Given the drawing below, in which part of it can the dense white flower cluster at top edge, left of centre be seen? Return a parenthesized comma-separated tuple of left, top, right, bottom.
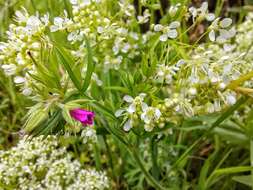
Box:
(50, 0, 140, 70)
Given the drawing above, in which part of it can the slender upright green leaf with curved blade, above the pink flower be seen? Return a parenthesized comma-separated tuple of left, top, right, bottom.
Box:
(82, 37, 95, 92)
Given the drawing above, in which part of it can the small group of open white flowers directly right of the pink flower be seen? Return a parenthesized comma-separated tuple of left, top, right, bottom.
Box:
(115, 93, 164, 131)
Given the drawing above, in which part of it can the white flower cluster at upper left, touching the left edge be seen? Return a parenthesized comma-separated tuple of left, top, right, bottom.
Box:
(0, 8, 49, 95)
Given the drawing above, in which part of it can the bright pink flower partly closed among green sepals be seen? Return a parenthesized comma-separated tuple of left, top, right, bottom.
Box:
(70, 109, 95, 125)
